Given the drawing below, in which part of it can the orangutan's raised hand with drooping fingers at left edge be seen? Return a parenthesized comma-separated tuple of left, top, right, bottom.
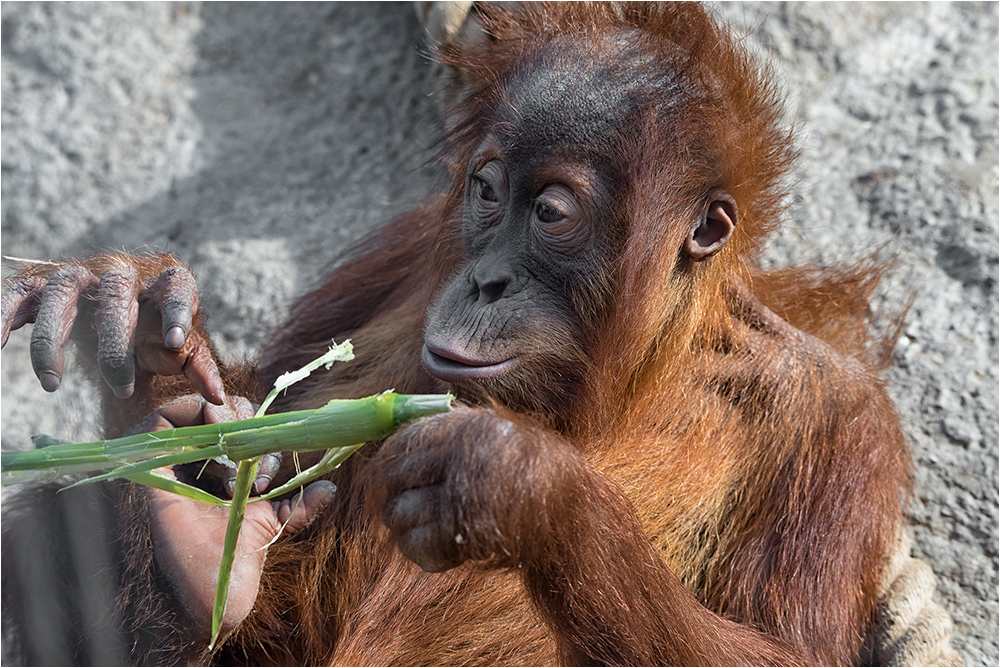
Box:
(2, 253, 225, 406)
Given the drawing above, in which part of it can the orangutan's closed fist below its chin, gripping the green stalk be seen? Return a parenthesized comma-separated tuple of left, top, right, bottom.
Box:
(367, 408, 590, 572)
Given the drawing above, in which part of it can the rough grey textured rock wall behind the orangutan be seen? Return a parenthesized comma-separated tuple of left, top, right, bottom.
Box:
(2, 2, 998, 665)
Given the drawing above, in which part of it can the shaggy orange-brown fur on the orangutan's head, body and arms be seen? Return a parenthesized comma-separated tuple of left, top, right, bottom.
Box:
(0, 3, 908, 665)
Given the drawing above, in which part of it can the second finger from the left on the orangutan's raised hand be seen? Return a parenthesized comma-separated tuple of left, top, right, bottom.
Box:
(31, 267, 97, 392)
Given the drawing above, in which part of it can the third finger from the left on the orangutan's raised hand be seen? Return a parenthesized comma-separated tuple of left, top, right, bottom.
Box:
(97, 264, 139, 399)
